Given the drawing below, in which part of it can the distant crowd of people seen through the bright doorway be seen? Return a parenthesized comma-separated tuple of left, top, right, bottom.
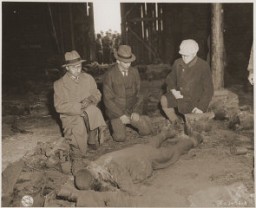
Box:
(95, 29, 121, 64)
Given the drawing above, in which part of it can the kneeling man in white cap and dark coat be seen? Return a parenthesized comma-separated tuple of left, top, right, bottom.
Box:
(161, 39, 213, 123)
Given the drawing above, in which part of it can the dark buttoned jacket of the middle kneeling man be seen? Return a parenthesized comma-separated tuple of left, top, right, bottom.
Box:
(103, 65, 142, 119)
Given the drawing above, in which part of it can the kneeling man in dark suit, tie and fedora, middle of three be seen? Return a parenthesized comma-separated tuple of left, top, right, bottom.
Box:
(103, 45, 152, 141)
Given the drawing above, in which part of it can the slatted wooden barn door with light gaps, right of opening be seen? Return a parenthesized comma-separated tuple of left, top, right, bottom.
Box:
(121, 3, 163, 64)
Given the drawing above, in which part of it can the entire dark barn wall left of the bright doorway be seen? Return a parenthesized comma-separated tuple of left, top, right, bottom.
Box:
(2, 2, 94, 77)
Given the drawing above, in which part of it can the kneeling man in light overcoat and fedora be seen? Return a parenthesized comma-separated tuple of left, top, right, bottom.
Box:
(54, 50, 106, 155)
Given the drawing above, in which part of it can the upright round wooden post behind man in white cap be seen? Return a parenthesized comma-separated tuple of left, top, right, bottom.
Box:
(211, 3, 224, 90)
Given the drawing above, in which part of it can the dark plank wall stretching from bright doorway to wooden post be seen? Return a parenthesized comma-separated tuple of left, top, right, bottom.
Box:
(121, 3, 210, 64)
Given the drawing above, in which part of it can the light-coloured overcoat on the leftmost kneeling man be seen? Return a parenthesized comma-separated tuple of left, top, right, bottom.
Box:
(54, 73, 105, 130)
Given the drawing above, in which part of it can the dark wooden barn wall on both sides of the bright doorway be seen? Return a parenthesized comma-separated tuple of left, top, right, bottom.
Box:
(2, 2, 253, 77)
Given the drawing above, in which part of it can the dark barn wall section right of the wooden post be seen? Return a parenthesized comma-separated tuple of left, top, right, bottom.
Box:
(223, 3, 253, 83)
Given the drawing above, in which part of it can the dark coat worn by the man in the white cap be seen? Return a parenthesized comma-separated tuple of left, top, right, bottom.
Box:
(166, 57, 213, 114)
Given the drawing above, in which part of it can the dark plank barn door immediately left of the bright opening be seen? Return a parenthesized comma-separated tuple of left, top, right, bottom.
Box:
(49, 3, 95, 60)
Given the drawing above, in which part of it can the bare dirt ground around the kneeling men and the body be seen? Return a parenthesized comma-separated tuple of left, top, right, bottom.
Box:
(2, 66, 255, 207)
